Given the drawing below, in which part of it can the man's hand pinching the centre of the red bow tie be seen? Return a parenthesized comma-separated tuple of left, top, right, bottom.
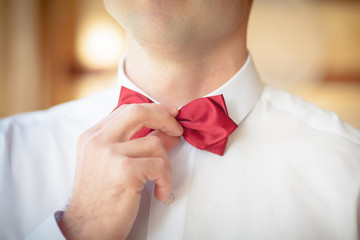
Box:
(59, 104, 183, 239)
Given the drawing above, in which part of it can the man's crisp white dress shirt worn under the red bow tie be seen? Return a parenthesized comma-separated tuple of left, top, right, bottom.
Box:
(0, 56, 360, 240)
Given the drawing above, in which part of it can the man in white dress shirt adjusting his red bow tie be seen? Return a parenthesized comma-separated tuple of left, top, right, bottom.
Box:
(0, 0, 360, 239)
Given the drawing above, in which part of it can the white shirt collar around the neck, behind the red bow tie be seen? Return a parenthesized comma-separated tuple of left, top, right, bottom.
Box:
(117, 55, 264, 124)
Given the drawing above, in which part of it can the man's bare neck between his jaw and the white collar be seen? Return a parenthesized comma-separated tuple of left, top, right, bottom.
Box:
(125, 30, 248, 107)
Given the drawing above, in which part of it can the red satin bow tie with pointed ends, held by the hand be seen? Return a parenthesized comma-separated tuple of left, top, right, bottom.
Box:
(116, 87, 237, 156)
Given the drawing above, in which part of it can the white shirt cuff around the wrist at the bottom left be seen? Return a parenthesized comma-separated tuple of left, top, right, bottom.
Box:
(25, 211, 66, 240)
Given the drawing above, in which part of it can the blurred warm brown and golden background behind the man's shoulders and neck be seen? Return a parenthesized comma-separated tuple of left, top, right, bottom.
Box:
(0, 0, 360, 129)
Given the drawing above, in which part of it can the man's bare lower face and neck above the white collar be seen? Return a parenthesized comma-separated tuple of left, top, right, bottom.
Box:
(105, 0, 251, 107)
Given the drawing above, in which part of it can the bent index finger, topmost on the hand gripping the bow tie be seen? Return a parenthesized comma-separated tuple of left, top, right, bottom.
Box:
(102, 103, 183, 141)
